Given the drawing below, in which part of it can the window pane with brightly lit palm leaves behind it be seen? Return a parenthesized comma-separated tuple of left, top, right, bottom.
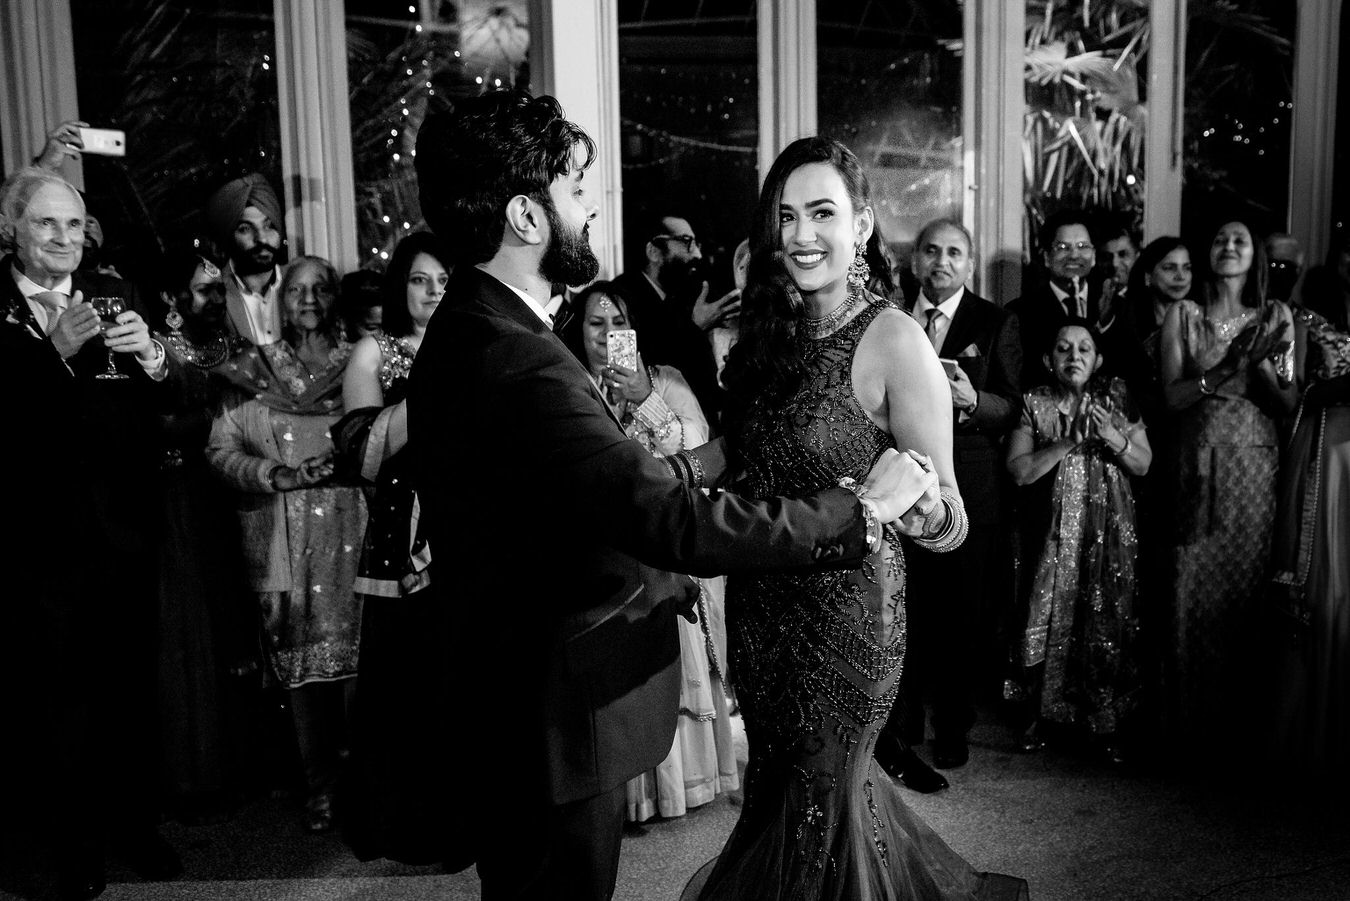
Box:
(1022, 0, 1149, 259)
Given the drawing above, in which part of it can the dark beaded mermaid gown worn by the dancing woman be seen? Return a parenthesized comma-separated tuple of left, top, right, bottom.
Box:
(686, 300, 1026, 901)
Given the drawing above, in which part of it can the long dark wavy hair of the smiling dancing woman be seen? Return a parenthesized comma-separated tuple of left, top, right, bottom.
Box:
(722, 136, 871, 438)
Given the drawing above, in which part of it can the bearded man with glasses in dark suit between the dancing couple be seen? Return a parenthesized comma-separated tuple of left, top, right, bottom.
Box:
(614, 209, 740, 428)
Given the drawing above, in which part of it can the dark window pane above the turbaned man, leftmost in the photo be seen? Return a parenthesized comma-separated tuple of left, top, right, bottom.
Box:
(69, 0, 281, 277)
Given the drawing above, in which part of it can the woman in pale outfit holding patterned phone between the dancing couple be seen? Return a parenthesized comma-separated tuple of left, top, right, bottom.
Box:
(564, 281, 740, 823)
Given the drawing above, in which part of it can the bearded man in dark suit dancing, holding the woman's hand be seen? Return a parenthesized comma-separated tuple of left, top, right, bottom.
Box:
(408, 92, 939, 901)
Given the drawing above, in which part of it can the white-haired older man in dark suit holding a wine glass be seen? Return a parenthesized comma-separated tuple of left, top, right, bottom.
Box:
(0, 169, 180, 898)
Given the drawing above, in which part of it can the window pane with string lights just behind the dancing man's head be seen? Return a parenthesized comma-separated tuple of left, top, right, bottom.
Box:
(346, 0, 529, 265)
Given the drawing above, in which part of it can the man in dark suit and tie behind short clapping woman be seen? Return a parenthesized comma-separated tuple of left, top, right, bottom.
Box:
(1007, 209, 1148, 388)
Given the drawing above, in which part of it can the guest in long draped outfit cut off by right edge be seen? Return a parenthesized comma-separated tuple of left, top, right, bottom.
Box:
(1272, 232, 1350, 789)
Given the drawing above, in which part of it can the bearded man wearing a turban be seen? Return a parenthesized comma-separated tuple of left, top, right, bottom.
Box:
(207, 173, 284, 344)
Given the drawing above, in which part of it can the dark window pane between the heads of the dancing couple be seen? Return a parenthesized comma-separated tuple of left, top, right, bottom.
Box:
(618, 0, 759, 282)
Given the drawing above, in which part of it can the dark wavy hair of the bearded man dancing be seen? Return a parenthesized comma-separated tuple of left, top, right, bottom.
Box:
(416, 89, 595, 265)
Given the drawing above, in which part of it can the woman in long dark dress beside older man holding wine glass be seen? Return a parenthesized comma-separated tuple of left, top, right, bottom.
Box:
(157, 253, 258, 823)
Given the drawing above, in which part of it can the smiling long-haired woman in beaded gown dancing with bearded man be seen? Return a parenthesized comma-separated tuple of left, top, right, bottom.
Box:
(684, 138, 1026, 901)
